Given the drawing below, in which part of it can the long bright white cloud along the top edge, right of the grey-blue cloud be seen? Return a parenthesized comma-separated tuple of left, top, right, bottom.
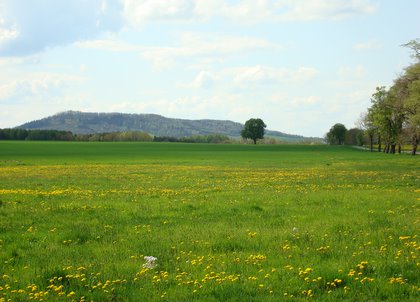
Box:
(124, 0, 376, 26)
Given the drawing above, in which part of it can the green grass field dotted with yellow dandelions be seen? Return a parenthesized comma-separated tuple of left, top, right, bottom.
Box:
(0, 142, 420, 301)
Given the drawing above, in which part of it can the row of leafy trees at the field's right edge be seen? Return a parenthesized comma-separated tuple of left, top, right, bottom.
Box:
(325, 39, 420, 155)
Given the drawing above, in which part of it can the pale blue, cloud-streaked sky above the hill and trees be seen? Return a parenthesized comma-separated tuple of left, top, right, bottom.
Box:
(0, 0, 420, 137)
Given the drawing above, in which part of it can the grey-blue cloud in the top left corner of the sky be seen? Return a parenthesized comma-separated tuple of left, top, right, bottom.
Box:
(0, 0, 122, 56)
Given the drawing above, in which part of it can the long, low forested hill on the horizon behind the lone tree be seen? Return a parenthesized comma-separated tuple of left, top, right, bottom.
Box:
(17, 111, 305, 141)
